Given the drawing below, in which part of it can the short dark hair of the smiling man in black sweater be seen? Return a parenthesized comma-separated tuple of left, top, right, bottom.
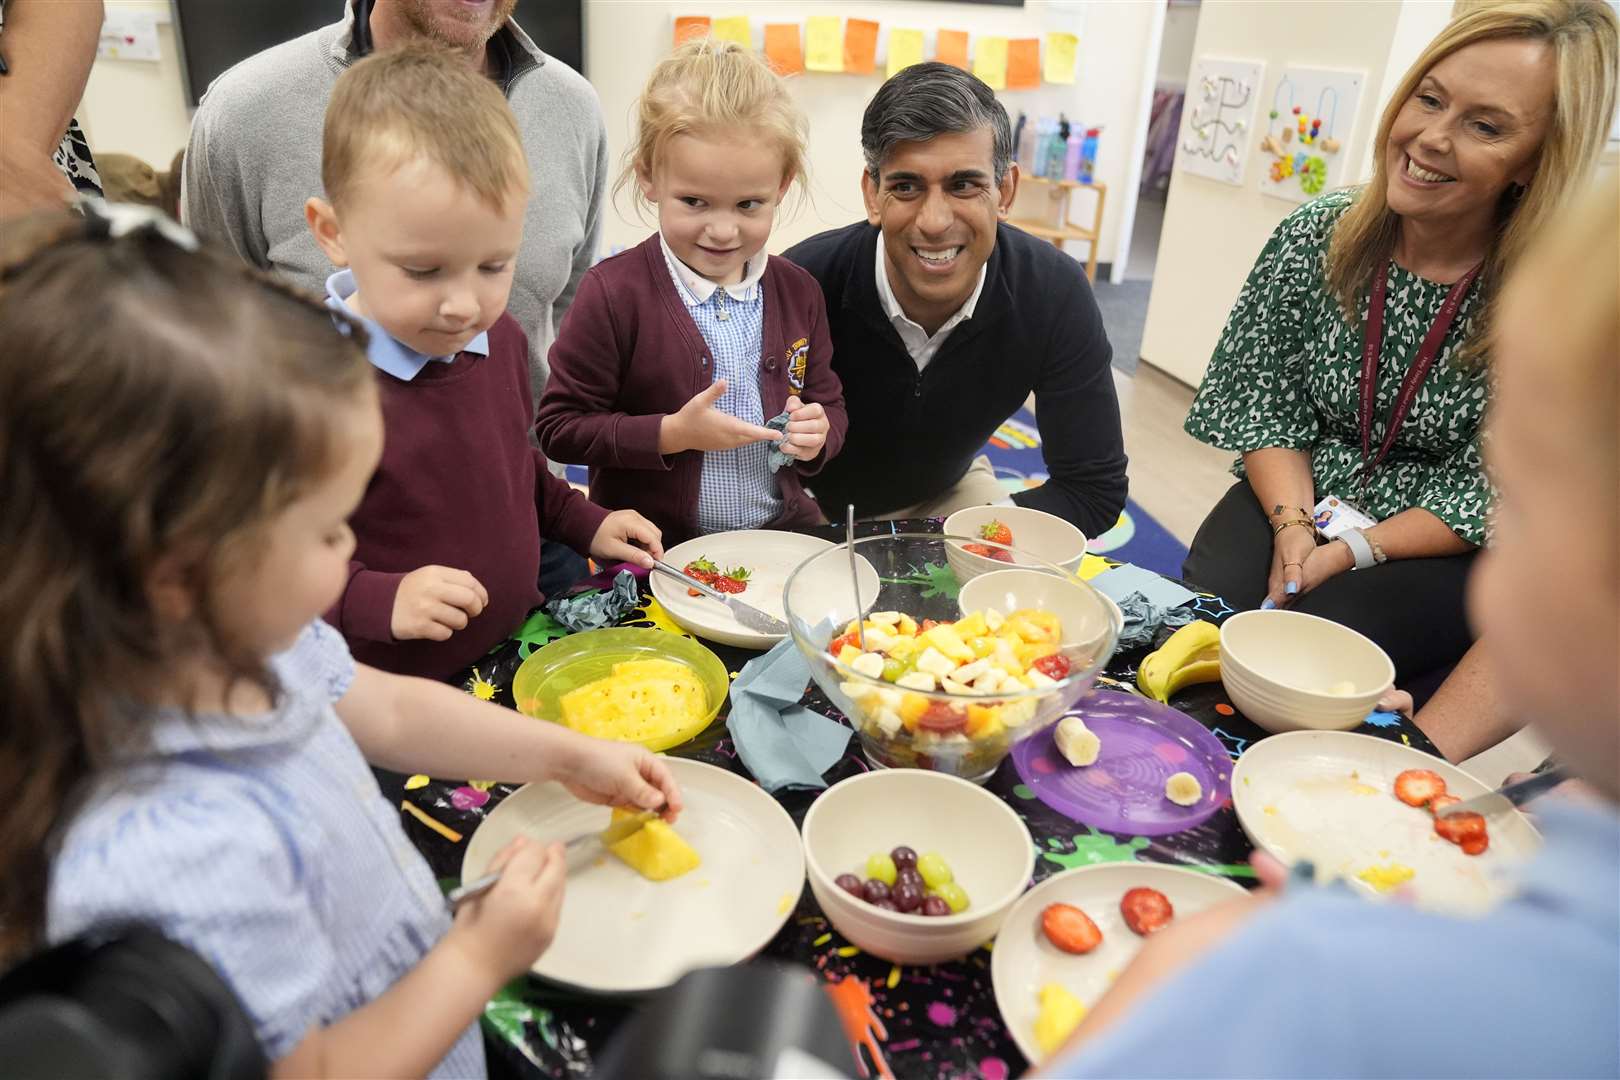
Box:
(860, 62, 1013, 185)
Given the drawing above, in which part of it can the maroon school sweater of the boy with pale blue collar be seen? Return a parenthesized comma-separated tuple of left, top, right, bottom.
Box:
(326, 314, 608, 678)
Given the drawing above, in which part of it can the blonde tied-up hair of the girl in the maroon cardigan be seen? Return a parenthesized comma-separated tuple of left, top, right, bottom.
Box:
(614, 37, 808, 207)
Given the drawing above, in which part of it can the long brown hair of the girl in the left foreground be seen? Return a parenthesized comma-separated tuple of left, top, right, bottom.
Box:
(0, 214, 374, 957)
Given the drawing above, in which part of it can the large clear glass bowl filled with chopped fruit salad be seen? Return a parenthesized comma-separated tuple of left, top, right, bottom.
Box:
(782, 533, 1119, 782)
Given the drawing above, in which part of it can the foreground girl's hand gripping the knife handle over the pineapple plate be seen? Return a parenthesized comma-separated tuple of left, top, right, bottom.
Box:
(446, 837, 569, 983)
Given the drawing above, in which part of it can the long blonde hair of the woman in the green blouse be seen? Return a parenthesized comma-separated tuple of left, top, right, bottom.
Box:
(1327, 0, 1620, 364)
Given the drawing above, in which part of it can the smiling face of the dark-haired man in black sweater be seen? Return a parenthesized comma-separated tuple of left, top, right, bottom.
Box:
(860, 126, 1017, 334)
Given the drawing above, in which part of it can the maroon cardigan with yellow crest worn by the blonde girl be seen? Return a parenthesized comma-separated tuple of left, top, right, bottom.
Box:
(535, 233, 849, 546)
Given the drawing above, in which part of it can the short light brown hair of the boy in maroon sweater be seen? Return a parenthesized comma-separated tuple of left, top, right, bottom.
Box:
(321, 45, 528, 209)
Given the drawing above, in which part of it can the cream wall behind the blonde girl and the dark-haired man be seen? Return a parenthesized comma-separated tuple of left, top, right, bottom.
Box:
(585, 0, 1162, 262)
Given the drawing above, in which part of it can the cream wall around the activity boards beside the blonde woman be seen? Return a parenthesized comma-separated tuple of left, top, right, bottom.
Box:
(1142, 0, 1452, 385)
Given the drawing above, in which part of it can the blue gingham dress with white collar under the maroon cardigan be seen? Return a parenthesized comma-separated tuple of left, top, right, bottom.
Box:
(663, 244, 782, 533)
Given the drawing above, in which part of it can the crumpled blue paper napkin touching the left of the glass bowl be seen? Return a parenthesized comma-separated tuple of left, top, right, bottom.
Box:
(726, 636, 851, 792)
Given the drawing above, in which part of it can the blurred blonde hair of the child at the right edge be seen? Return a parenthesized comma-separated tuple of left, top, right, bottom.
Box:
(1503, 175, 1620, 563)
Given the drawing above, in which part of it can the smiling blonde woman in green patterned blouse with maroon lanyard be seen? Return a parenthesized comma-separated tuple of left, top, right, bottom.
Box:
(1183, 0, 1620, 678)
